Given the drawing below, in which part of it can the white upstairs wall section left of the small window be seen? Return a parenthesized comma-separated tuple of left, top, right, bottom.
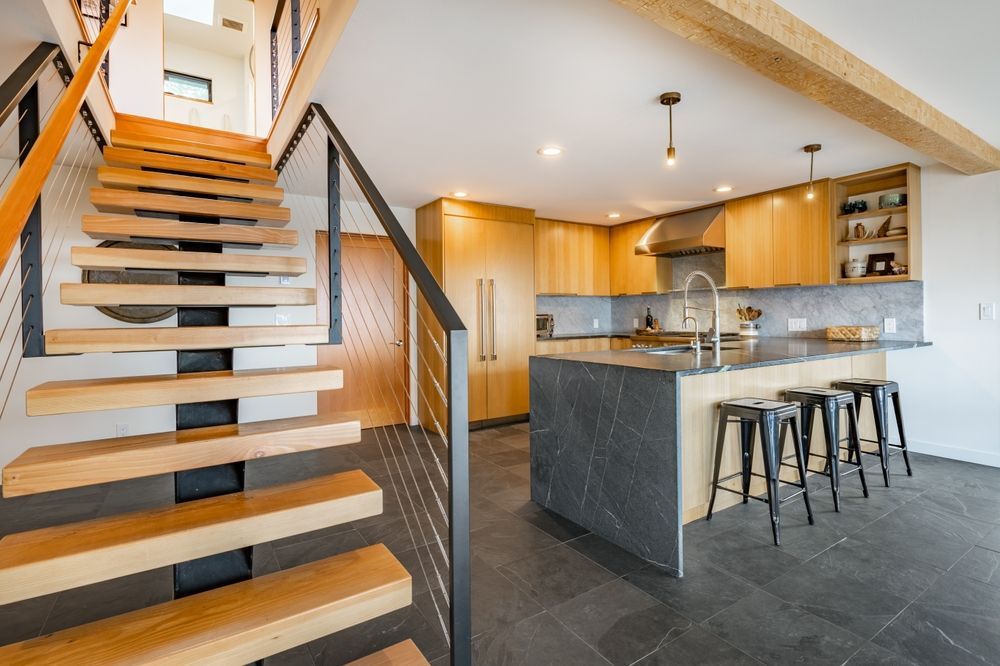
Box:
(108, 0, 163, 118)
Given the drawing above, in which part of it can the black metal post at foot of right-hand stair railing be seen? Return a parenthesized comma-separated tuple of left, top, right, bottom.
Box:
(447, 329, 472, 666)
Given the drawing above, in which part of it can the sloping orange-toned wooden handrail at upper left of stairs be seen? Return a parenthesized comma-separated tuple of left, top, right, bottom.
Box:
(0, 1, 131, 266)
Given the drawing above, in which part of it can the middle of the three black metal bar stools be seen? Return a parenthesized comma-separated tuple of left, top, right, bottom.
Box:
(785, 386, 868, 511)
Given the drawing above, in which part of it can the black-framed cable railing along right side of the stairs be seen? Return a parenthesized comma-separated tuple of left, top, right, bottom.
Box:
(277, 104, 471, 664)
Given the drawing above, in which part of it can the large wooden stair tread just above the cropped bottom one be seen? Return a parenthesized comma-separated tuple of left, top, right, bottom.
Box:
(0, 545, 412, 666)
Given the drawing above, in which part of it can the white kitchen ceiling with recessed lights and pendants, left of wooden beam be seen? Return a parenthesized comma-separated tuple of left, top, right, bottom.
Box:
(315, 0, 1000, 223)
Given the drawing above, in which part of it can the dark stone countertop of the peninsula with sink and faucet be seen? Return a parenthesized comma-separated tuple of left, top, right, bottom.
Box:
(532, 337, 931, 375)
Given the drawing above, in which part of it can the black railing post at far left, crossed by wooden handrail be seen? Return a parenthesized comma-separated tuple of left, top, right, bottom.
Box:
(17, 82, 45, 358)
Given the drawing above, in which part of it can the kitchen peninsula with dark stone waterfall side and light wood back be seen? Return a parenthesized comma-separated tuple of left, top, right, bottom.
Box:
(530, 338, 928, 575)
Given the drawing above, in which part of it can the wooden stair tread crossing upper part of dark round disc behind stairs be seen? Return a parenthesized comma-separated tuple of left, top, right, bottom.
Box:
(70, 245, 306, 275)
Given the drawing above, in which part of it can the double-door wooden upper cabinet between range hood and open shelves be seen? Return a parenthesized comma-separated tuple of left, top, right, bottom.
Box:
(726, 180, 831, 289)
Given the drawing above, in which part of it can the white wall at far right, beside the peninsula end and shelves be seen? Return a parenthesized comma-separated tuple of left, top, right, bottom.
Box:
(888, 165, 1000, 467)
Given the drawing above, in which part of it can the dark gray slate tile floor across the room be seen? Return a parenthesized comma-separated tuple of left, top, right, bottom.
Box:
(0, 424, 1000, 666)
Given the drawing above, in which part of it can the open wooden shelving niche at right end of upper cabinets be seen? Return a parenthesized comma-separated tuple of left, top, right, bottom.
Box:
(830, 163, 921, 284)
